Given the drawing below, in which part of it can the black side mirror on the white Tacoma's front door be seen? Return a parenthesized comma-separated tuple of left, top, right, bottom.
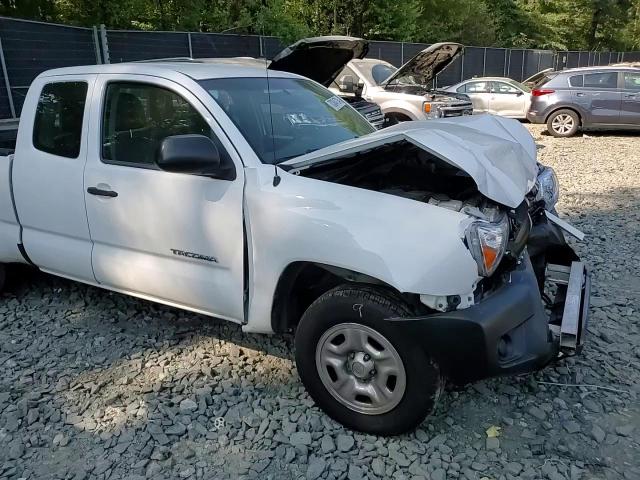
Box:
(156, 135, 221, 175)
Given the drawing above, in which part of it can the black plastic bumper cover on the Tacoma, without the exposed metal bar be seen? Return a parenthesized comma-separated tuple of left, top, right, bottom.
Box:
(389, 255, 558, 384)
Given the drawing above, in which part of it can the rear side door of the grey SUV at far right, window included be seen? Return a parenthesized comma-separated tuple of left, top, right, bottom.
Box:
(572, 71, 622, 124)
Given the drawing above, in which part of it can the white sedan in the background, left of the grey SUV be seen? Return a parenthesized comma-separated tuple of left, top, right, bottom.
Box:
(444, 77, 531, 119)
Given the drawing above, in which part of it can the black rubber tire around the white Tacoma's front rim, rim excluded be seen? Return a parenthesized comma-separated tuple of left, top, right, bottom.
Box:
(295, 285, 444, 435)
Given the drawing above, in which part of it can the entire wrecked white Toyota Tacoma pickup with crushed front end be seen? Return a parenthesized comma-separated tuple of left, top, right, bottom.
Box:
(0, 62, 589, 434)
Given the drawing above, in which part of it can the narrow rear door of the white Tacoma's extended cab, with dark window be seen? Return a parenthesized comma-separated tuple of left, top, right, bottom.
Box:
(12, 75, 96, 283)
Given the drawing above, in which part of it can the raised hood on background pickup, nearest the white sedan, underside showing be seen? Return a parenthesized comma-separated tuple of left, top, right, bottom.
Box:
(381, 42, 464, 86)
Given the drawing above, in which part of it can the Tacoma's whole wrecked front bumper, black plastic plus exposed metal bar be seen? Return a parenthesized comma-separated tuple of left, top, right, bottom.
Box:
(391, 251, 590, 384)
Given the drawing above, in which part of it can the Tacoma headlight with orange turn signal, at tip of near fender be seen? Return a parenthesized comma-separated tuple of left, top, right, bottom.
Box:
(466, 216, 509, 277)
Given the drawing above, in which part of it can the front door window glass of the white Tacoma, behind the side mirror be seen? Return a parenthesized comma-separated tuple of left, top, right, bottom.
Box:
(102, 82, 225, 168)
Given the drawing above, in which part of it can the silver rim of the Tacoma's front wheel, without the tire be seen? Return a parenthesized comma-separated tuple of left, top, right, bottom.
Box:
(316, 323, 407, 415)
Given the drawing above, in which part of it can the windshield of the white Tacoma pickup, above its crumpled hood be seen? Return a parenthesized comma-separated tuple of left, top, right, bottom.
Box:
(199, 78, 375, 164)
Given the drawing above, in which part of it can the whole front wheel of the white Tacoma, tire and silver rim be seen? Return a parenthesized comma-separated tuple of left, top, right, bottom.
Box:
(295, 285, 443, 435)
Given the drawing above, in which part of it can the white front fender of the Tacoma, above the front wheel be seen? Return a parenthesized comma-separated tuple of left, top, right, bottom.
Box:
(245, 165, 478, 332)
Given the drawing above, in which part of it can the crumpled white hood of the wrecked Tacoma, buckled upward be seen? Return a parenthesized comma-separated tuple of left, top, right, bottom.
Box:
(280, 115, 538, 208)
